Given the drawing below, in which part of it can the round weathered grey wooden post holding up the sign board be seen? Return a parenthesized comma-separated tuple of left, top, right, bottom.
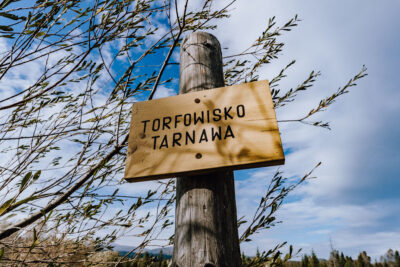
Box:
(173, 32, 242, 267)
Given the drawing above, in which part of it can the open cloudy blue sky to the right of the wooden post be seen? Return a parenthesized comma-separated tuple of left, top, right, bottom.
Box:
(203, 0, 400, 258)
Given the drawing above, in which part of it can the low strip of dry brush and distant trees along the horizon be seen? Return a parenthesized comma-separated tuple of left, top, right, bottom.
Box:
(0, 231, 400, 267)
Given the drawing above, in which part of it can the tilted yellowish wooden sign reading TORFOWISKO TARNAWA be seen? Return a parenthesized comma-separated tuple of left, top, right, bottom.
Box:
(125, 81, 285, 182)
